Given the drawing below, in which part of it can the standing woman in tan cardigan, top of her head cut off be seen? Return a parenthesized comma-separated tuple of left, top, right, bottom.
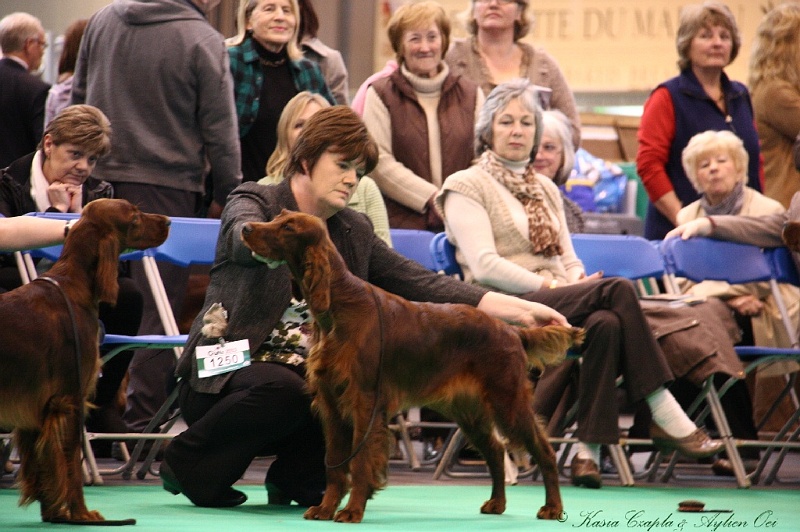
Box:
(444, 0, 581, 148)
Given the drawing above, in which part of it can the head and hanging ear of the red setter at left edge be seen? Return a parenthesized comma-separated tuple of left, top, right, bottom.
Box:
(64, 199, 169, 304)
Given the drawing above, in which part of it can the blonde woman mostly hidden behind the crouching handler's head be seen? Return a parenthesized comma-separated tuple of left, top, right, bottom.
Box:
(258, 91, 392, 246)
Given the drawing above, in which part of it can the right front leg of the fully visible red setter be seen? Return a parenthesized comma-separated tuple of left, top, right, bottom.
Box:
(334, 394, 389, 523)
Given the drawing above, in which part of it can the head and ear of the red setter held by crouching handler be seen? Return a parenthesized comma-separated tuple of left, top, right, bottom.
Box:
(242, 209, 332, 313)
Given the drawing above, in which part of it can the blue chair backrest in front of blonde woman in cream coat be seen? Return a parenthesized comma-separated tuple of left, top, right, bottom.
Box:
(661, 237, 772, 284)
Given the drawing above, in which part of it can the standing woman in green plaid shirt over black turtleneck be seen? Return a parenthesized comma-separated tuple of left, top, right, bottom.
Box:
(228, 0, 336, 181)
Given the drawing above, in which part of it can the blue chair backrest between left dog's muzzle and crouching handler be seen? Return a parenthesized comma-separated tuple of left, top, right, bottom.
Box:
(146, 216, 220, 267)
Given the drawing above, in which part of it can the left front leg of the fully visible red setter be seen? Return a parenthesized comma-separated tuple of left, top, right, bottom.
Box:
(303, 391, 353, 521)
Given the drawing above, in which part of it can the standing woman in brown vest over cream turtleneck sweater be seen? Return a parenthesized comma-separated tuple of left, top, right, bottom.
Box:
(364, 2, 483, 231)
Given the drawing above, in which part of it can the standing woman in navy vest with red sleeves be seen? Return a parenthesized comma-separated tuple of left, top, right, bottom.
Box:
(636, 2, 763, 240)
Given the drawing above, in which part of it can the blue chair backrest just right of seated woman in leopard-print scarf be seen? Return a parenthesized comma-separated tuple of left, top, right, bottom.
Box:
(572, 233, 664, 279)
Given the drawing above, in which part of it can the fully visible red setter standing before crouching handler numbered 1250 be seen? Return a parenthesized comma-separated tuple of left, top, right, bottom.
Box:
(242, 211, 583, 523)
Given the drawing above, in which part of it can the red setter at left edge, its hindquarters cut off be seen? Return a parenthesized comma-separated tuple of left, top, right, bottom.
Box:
(0, 199, 169, 524)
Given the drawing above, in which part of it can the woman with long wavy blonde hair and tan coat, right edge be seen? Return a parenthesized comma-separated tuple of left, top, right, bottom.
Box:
(748, 3, 800, 208)
